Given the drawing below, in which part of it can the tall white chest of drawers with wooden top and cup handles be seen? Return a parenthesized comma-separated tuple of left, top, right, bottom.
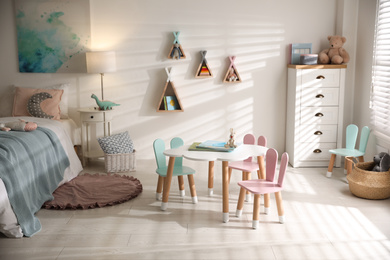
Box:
(286, 65, 347, 167)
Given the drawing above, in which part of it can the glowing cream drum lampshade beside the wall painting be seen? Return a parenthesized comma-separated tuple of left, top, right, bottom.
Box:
(86, 51, 116, 73)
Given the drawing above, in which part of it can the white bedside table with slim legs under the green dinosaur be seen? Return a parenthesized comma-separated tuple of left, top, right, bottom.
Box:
(78, 108, 113, 166)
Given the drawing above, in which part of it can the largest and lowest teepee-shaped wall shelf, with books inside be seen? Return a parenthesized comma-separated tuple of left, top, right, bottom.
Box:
(157, 67, 183, 112)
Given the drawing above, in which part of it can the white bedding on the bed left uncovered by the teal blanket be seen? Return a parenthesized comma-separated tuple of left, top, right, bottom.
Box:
(0, 117, 82, 238)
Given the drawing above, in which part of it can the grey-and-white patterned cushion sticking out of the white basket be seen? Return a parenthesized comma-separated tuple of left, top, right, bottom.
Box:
(97, 132, 134, 154)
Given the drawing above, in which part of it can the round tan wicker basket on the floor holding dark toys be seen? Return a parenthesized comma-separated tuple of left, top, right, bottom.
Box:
(347, 158, 390, 200)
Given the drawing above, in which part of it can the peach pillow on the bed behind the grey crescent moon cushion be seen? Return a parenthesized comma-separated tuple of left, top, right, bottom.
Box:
(12, 87, 64, 120)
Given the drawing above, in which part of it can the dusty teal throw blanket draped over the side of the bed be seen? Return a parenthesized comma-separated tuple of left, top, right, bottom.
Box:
(0, 127, 69, 237)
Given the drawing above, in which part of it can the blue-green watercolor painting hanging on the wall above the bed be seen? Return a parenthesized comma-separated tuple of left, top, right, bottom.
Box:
(15, 0, 91, 73)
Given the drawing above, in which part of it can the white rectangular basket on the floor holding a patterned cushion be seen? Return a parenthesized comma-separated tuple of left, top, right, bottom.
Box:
(104, 150, 136, 173)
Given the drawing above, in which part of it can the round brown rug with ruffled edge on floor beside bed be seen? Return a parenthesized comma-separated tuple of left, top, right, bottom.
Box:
(42, 173, 142, 209)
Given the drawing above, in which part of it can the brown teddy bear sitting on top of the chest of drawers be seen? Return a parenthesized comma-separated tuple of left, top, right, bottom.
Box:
(318, 35, 349, 64)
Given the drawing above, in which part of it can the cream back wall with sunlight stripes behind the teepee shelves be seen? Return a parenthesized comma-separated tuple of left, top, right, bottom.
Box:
(0, 0, 353, 158)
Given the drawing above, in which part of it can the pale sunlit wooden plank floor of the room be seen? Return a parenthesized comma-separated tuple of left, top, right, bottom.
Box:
(0, 160, 390, 260)
